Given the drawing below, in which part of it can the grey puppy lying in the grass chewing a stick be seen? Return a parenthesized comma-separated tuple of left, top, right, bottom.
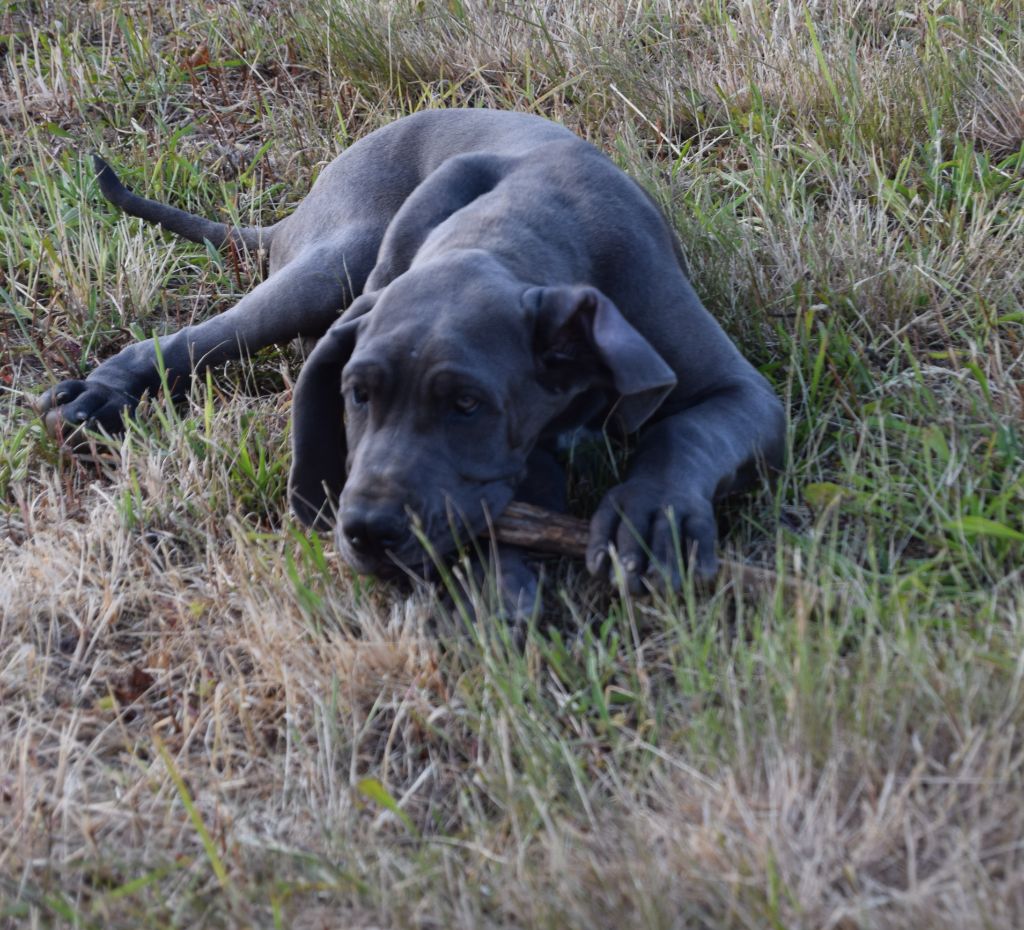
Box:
(39, 110, 784, 590)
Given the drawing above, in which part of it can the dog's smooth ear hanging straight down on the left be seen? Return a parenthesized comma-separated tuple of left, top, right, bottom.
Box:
(288, 294, 376, 530)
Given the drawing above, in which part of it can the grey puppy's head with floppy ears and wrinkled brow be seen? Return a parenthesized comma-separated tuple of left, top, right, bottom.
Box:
(290, 252, 676, 576)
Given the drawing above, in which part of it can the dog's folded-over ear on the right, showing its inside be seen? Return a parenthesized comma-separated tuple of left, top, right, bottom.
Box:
(523, 286, 677, 432)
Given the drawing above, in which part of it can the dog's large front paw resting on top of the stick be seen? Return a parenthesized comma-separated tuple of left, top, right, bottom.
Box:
(587, 479, 718, 594)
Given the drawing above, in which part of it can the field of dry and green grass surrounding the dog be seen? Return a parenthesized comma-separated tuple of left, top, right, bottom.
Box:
(0, 0, 1024, 930)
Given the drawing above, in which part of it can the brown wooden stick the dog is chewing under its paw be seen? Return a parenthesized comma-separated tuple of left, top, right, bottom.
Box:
(492, 501, 820, 606)
